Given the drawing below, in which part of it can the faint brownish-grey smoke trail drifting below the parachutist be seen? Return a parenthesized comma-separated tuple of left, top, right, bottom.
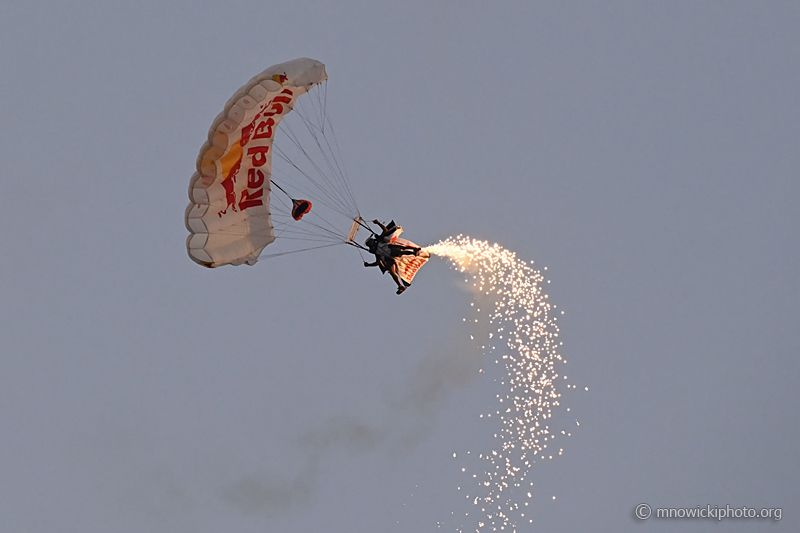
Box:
(217, 286, 484, 515)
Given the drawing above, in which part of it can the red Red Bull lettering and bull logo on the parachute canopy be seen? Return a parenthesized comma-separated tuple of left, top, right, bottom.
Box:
(217, 88, 294, 218)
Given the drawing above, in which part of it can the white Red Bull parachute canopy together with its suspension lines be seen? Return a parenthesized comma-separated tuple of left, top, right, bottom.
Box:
(186, 58, 360, 268)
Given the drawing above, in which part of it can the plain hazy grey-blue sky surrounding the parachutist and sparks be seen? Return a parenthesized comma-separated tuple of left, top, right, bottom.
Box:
(0, 0, 800, 533)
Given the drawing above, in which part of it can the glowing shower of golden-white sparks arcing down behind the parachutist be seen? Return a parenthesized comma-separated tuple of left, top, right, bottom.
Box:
(426, 236, 575, 533)
